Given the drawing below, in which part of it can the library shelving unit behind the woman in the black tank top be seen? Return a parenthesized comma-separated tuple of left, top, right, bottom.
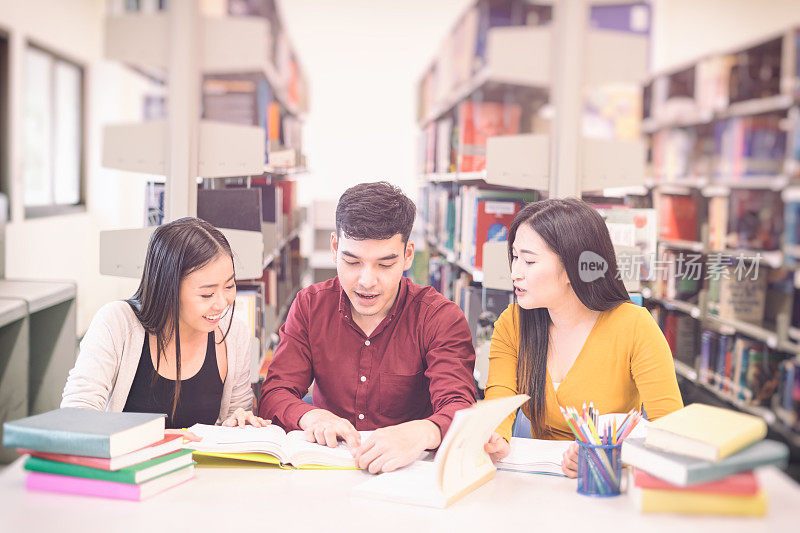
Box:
(100, 0, 307, 383)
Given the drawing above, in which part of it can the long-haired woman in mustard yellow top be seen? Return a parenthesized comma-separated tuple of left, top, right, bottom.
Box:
(486, 198, 683, 477)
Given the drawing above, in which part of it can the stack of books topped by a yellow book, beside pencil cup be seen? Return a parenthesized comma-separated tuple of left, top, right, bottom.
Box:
(622, 403, 789, 516)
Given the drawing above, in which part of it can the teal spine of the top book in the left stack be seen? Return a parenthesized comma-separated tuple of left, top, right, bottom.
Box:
(3, 423, 111, 459)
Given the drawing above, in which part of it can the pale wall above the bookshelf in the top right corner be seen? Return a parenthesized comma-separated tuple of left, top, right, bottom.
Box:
(652, 0, 800, 71)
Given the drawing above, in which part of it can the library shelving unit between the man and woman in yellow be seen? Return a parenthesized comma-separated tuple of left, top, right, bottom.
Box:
(412, 0, 650, 385)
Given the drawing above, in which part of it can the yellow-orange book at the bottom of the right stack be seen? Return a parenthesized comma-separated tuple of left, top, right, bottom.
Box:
(642, 489, 767, 516)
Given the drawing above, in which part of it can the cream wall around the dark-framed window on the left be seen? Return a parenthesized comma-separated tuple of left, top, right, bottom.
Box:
(0, 0, 148, 334)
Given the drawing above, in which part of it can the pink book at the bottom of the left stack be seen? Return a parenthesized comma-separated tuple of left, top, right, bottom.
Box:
(25, 465, 194, 501)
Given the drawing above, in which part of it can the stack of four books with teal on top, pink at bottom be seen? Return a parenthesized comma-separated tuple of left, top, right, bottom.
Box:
(3, 408, 194, 500)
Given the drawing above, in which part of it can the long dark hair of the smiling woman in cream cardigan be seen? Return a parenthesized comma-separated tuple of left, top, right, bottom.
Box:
(127, 217, 233, 417)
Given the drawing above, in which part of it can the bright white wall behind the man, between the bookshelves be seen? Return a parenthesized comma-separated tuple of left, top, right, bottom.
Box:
(279, 0, 473, 204)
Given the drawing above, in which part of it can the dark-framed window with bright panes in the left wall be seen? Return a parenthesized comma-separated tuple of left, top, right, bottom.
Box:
(22, 45, 84, 217)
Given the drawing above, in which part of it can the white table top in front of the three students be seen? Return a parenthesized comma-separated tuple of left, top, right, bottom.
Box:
(0, 458, 800, 533)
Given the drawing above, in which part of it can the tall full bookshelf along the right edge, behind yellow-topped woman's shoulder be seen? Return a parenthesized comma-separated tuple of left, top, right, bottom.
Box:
(642, 28, 800, 446)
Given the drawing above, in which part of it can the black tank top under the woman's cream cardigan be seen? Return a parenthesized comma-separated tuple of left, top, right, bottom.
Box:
(123, 332, 223, 429)
